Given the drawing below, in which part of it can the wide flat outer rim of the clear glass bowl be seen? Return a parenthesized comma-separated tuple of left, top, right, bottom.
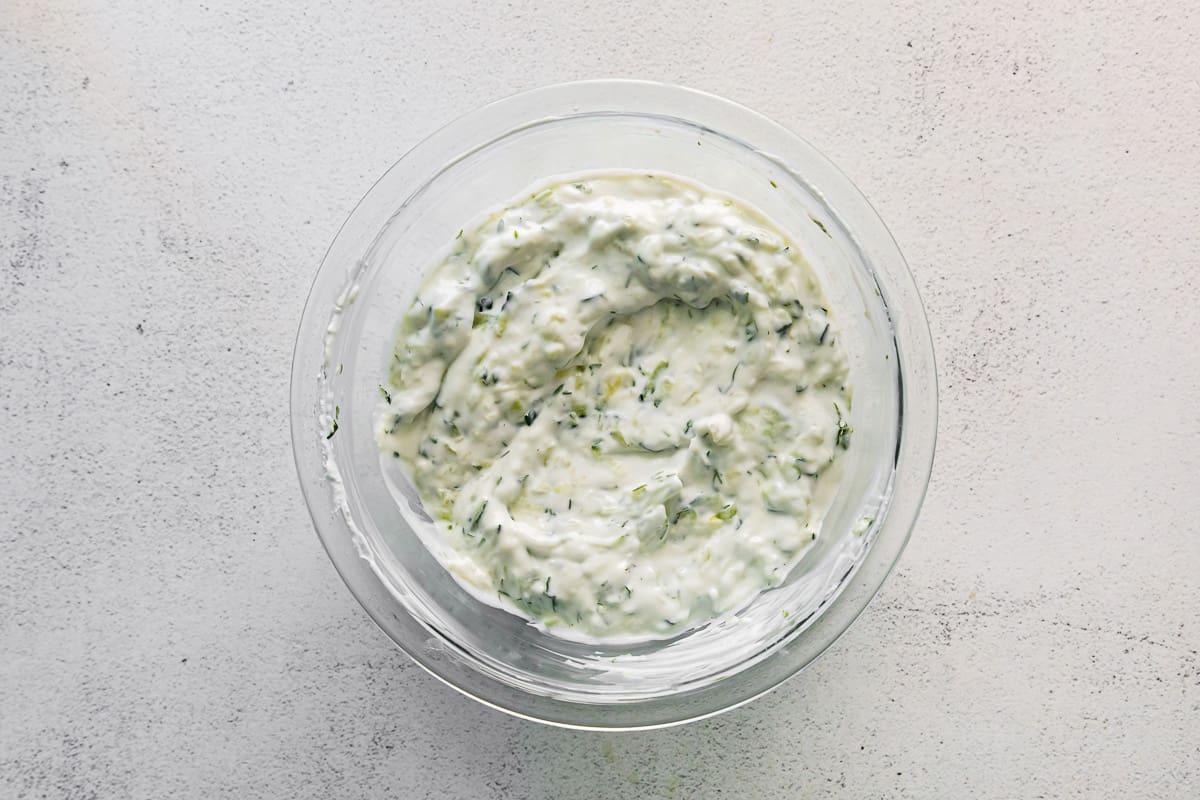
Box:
(290, 79, 937, 730)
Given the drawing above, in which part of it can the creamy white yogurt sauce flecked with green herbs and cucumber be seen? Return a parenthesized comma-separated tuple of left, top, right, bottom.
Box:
(377, 172, 851, 638)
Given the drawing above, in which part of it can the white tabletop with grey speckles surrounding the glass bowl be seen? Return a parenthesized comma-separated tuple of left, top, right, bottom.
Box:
(0, 0, 1200, 799)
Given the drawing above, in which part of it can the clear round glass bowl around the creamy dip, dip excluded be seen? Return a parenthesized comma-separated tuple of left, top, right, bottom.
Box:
(292, 80, 937, 729)
